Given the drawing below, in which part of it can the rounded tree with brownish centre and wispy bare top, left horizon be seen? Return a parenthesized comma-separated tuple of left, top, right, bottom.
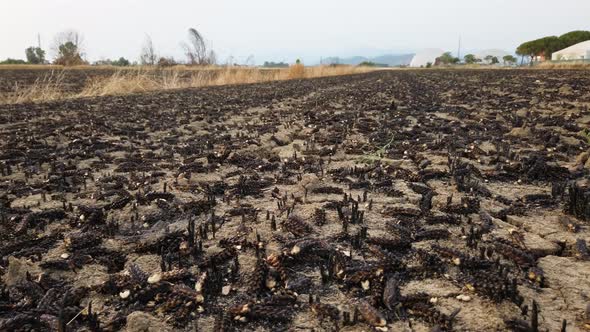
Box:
(52, 30, 86, 66)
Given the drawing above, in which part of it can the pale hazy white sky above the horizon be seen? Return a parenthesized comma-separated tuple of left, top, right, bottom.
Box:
(0, 0, 590, 63)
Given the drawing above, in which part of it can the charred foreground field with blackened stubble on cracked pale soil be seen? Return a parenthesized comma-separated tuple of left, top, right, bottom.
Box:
(0, 70, 590, 331)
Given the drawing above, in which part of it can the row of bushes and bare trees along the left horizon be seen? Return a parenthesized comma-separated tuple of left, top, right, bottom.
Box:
(0, 28, 217, 67)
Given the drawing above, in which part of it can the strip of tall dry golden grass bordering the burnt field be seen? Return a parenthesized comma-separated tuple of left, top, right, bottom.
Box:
(0, 65, 375, 104)
